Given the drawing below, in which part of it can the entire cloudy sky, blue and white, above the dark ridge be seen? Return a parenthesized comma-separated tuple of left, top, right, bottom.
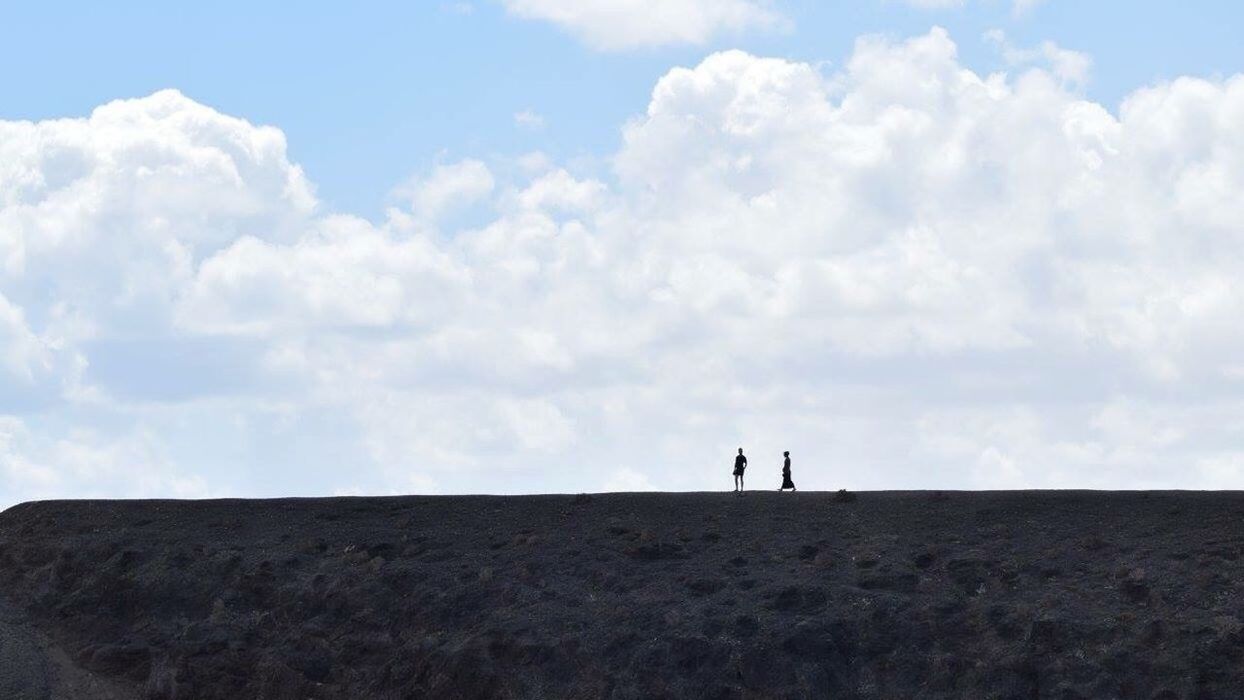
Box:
(0, 0, 1244, 505)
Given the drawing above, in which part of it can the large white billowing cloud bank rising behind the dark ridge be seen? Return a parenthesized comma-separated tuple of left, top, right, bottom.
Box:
(0, 30, 1244, 502)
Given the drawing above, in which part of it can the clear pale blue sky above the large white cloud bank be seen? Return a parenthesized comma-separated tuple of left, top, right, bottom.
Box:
(0, 0, 1244, 216)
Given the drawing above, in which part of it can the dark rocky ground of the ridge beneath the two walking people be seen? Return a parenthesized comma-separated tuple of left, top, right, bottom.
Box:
(0, 492, 1244, 699)
